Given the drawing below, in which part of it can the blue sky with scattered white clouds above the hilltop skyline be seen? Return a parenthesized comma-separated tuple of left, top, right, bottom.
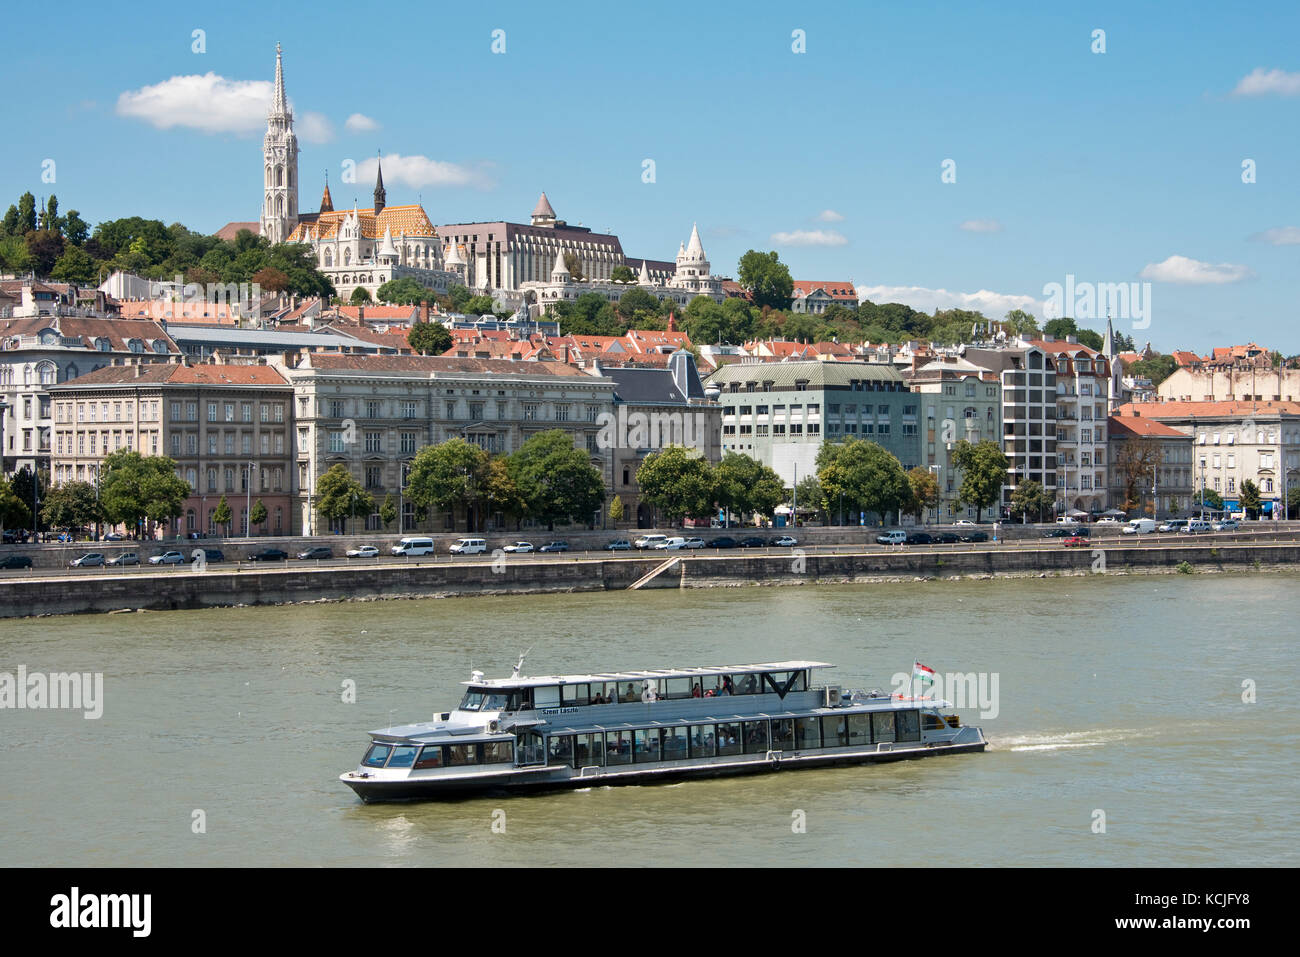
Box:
(0, 3, 1300, 354)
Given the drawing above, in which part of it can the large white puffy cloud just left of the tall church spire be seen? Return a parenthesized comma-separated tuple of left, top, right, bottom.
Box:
(117, 73, 273, 135)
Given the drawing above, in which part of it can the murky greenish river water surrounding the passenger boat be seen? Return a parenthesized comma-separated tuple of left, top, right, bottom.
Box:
(0, 575, 1300, 867)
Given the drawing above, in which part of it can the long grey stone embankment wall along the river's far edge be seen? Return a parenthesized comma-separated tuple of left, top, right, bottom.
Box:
(0, 542, 1300, 618)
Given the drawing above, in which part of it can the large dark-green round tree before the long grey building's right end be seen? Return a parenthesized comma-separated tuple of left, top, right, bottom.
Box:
(510, 429, 605, 528)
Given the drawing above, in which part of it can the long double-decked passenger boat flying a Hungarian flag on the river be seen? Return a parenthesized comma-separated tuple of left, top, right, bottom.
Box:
(339, 658, 987, 801)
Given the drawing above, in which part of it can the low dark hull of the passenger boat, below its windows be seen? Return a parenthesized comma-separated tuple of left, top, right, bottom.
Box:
(339, 735, 988, 804)
